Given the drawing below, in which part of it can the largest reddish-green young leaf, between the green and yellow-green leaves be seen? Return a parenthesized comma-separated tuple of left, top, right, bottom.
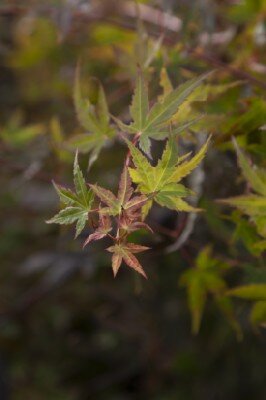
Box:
(90, 167, 148, 217)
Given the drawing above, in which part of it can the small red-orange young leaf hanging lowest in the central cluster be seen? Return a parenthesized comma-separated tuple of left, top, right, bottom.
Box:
(106, 243, 149, 279)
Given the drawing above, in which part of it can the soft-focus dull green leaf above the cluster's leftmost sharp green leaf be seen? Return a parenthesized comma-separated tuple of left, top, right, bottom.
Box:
(67, 62, 115, 166)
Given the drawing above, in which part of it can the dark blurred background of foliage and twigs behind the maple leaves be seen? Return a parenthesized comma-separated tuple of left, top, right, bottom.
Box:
(0, 0, 266, 400)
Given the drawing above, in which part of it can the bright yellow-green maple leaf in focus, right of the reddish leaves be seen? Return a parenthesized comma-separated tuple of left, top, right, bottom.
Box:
(126, 137, 209, 216)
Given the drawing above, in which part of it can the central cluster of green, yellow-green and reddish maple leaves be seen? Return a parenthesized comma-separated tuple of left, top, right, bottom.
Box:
(47, 70, 209, 278)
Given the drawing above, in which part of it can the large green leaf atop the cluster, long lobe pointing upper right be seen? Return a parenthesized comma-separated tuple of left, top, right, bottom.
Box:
(115, 71, 210, 155)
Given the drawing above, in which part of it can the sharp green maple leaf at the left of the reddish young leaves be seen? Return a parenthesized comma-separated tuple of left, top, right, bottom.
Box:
(46, 153, 94, 237)
